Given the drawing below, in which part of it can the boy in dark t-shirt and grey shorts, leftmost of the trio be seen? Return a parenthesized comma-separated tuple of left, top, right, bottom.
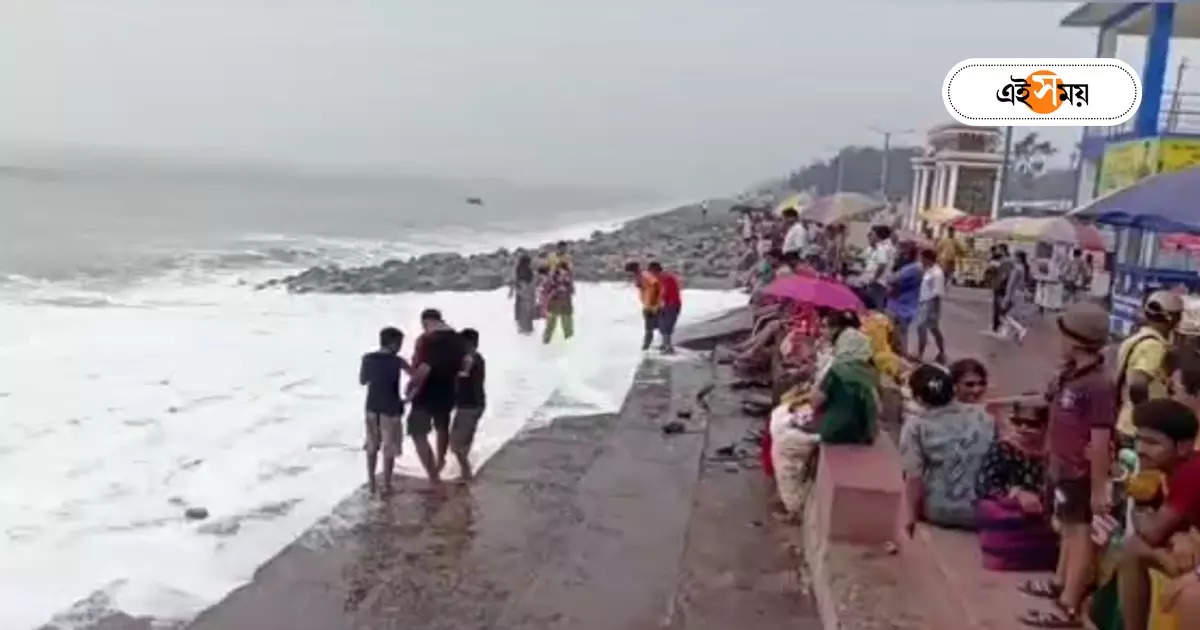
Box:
(359, 326, 410, 494)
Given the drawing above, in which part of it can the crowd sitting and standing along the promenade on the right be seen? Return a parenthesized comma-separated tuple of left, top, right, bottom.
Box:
(728, 205, 1200, 630)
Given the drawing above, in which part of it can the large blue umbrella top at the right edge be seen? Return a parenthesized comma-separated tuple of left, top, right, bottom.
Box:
(1069, 167, 1200, 234)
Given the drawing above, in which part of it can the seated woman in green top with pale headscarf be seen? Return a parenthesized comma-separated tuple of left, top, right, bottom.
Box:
(806, 311, 880, 444)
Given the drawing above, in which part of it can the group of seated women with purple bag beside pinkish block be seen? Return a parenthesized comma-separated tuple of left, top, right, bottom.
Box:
(900, 359, 1057, 571)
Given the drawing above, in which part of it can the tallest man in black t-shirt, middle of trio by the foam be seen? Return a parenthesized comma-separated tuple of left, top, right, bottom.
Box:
(408, 308, 466, 482)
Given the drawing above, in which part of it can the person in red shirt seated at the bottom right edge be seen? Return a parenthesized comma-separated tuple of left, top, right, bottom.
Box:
(1096, 398, 1200, 630)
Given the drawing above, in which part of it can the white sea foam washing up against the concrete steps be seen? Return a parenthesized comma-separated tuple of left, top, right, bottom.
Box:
(0, 268, 743, 629)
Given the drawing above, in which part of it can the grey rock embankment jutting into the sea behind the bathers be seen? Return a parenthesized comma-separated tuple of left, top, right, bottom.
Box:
(267, 206, 744, 293)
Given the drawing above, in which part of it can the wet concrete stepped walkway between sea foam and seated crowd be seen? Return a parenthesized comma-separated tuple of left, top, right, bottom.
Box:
(190, 361, 820, 630)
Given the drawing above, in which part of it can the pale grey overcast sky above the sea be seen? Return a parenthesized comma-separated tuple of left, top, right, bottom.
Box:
(0, 0, 1190, 193)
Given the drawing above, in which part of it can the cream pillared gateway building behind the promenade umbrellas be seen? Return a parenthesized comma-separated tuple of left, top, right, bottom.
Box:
(906, 122, 1004, 229)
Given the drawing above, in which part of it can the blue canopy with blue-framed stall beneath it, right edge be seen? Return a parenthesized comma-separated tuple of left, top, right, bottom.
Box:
(1070, 168, 1200, 335)
